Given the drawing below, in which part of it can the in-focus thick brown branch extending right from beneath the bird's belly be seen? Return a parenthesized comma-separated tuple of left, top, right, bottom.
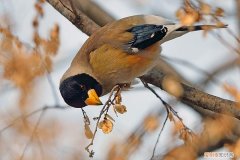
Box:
(141, 62, 240, 119)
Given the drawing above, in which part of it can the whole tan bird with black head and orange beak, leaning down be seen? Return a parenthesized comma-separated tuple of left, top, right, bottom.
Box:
(59, 15, 225, 108)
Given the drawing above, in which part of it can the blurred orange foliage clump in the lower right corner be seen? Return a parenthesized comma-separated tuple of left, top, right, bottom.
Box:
(163, 116, 235, 160)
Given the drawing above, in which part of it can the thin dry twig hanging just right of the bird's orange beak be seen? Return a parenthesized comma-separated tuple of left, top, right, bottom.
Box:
(85, 85, 120, 157)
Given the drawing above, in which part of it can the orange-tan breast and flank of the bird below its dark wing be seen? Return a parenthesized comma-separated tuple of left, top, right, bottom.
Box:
(90, 44, 160, 92)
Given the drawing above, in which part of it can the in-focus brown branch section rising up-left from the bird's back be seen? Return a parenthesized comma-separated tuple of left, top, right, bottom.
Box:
(47, 0, 99, 35)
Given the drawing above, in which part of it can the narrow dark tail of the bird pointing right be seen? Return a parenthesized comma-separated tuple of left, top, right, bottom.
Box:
(176, 25, 228, 32)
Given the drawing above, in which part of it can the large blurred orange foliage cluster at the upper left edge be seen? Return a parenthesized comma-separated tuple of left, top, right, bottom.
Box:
(0, 2, 60, 107)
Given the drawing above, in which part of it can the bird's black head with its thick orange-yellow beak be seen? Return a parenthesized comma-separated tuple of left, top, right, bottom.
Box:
(59, 73, 102, 108)
